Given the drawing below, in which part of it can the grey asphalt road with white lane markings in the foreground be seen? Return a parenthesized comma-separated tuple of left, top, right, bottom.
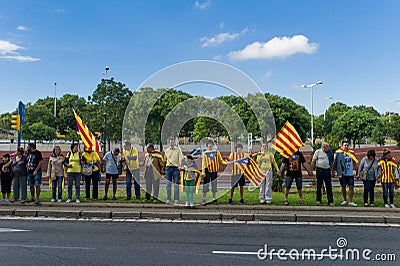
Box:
(0, 220, 400, 265)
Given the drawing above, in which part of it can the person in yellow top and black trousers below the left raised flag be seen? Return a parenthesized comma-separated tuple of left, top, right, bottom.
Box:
(82, 148, 102, 200)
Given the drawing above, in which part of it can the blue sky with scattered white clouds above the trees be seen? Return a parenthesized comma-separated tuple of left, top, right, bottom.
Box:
(0, 0, 400, 115)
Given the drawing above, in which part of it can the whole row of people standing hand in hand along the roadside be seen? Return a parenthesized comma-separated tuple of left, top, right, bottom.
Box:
(0, 138, 399, 208)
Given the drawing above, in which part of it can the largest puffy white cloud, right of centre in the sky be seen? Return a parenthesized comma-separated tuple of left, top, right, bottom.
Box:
(228, 35, 319, 60)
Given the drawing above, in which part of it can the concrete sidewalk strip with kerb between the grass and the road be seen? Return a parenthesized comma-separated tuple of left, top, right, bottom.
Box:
(0, 202, 400, 224)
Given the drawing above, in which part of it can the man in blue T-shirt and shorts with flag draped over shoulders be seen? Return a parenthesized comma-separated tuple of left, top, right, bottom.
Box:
(332, 141, 358, 207)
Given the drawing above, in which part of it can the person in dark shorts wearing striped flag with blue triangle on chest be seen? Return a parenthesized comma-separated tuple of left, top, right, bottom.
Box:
(201, 139, 228, 205)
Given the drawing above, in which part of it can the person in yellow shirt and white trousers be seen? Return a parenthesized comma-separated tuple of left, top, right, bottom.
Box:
(256, 143, 279, 204)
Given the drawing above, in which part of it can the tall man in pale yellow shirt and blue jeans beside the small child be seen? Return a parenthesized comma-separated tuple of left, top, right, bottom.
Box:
(164, 138, 183, 204)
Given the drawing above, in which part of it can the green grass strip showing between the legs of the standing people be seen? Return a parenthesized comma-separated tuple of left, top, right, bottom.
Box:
(11, 184, 400, 207)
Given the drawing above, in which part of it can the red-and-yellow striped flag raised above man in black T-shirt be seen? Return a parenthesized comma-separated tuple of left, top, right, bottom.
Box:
(271, 121, 304, 158)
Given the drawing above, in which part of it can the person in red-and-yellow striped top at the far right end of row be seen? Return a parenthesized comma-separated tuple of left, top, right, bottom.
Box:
(377, 148, 399, 208)
